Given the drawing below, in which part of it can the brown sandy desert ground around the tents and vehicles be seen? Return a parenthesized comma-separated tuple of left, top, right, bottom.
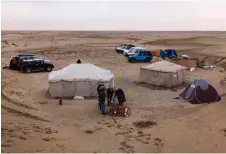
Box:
(1, 32, 226, 152)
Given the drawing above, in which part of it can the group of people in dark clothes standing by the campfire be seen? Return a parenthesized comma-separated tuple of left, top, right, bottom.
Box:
(97, 84, 126, 115)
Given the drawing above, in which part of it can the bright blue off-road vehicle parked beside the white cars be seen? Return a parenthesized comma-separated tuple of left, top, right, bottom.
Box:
(128, 50, 153, 62)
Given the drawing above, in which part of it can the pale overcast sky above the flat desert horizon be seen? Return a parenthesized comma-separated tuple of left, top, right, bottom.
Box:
(1, 0, 226, 31)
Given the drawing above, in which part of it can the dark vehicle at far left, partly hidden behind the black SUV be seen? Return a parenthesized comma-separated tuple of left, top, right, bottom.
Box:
(9, 54, 35, 70)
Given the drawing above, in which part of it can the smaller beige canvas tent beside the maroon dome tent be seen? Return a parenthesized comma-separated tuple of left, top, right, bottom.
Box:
(139, 61, 186, 87)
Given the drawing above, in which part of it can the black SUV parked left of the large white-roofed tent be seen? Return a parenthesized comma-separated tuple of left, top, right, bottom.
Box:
(20, 56, 54, 73)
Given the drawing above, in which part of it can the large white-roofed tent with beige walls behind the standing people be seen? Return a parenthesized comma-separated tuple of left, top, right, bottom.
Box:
(48, 64, 114, 97)
